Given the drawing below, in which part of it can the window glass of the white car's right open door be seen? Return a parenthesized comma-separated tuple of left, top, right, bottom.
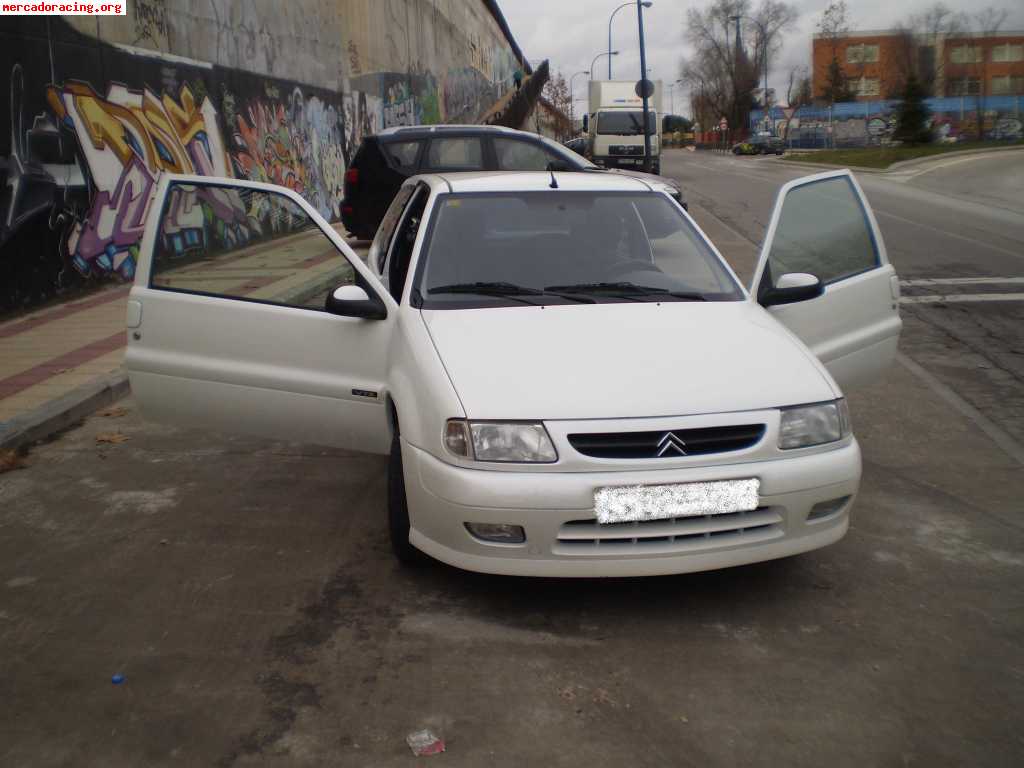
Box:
(766, 176, 881, 285)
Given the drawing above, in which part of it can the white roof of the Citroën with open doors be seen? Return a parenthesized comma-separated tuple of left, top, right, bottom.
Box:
(406, 171, 652, 194)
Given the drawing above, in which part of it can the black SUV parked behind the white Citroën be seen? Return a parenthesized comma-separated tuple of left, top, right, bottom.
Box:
(341, 125, 686, 240)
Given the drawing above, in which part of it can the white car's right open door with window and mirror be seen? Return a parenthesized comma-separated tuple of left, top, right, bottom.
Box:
(753, 170, 902, 390)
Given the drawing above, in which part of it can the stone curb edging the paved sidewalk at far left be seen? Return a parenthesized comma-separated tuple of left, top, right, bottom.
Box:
(0, 371, 130, 451)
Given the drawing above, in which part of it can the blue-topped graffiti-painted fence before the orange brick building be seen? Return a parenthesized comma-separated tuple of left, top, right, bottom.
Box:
(749, 96, 1024, 148)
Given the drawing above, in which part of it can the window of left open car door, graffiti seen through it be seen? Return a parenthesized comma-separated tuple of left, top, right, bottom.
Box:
(150, 181, 355, 310)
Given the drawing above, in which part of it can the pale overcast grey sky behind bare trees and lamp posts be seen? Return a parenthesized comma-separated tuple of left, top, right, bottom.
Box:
(499, 0, 1024, 115)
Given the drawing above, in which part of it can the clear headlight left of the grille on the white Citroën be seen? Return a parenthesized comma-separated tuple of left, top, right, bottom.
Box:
(444, 419, 558, 464)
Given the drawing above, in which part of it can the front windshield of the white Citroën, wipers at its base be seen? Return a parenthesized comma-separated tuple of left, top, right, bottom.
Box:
(414, 190, 743, 309)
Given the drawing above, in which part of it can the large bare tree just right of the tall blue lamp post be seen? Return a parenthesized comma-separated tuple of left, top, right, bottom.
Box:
(680, 0, 796, 140)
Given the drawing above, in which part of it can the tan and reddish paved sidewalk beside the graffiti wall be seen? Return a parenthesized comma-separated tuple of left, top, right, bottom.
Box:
(0, 234, 367, 447)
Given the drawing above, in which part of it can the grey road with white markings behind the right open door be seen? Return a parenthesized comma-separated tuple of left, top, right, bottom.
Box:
(663, 151, 1024, 451)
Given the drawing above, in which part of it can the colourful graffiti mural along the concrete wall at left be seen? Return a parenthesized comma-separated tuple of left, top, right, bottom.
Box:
(0, 14, 520, 311)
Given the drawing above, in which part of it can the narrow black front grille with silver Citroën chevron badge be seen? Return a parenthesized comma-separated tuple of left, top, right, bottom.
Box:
(569, 424, 765, 459)
